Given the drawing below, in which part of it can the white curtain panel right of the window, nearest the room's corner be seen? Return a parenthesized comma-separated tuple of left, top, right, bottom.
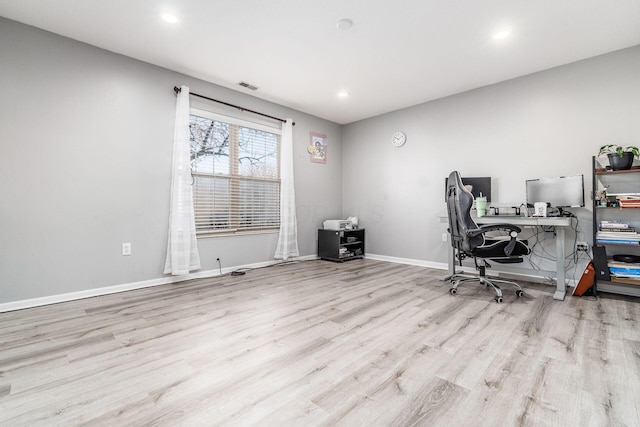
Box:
(274, 119, 299, 260)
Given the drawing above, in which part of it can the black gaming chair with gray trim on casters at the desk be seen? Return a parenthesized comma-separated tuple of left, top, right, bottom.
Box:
(446, 171, 531, 303)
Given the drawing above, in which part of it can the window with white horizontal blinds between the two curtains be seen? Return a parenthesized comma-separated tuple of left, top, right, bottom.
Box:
(189, 109, 280, 236)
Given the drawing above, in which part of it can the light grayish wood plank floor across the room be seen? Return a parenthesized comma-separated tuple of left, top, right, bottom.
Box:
(0, 259, 640, 426)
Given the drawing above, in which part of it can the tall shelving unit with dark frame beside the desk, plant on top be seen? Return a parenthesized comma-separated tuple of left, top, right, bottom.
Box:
(591, 156, 640, 296)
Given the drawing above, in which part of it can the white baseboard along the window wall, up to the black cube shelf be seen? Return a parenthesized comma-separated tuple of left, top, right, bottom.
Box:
(0, 255, 317, 313)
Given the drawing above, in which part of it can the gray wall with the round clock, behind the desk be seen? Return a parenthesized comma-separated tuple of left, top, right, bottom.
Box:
(343, 47, 640, 273)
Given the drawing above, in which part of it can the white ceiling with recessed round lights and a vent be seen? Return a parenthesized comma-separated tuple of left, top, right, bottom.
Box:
(0, 0, 640, 124)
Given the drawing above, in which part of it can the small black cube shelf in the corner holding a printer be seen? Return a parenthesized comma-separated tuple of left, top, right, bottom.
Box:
(318, 228, 364, 262)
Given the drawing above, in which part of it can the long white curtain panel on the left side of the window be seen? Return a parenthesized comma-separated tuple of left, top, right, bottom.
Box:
(164, 86, 200, 276)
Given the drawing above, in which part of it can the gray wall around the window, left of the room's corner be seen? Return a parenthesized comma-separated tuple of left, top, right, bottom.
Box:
(0, 18, 342, 304)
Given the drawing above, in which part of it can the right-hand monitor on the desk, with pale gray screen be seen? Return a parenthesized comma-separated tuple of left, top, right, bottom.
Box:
(526, 175, 584, 208)
